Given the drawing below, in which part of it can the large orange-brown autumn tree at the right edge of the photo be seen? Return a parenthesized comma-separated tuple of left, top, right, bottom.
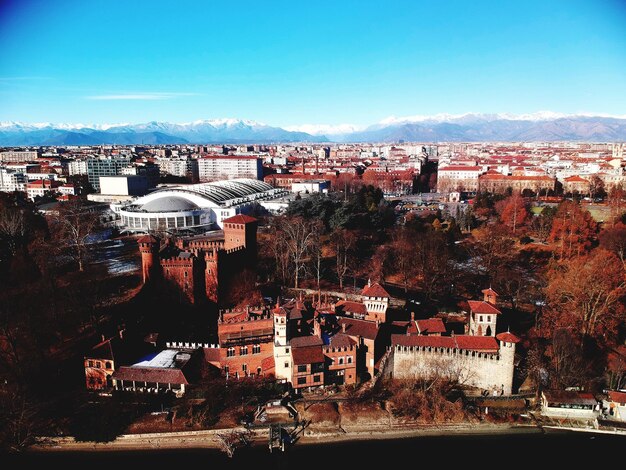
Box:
(544, 248, 626, 338)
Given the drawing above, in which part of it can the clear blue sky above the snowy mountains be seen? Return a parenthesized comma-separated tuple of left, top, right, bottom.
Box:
(0, 0, 626, 126)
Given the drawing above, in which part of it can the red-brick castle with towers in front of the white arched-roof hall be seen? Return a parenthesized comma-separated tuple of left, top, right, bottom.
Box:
(137, 214, 257, 304)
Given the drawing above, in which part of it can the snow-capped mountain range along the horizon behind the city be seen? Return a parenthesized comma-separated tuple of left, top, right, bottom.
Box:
(0, 111, 626, 146)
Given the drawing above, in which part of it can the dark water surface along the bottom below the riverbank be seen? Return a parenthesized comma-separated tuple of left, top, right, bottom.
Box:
(2, 431, 626, 470)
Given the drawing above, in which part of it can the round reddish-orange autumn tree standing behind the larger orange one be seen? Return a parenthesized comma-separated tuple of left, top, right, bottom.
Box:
(549, 201, 597, 258)
